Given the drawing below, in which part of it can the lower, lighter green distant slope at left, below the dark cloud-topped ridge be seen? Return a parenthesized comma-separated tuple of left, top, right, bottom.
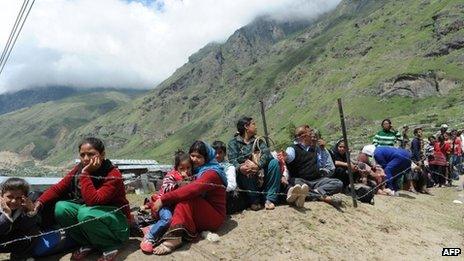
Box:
(0, 90, 147, 159)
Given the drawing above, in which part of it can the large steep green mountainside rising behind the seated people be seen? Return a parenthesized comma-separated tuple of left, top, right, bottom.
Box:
(0, 0, 464, 164)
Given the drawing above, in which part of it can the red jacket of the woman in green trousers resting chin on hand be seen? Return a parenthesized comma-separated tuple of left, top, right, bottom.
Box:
(37, 165, 130, 220)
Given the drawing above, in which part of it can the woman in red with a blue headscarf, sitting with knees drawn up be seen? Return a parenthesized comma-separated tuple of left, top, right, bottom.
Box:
(153, 141, 227, 255)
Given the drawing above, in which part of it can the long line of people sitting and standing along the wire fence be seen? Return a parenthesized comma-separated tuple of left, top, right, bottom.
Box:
(0, 117, 462, 261)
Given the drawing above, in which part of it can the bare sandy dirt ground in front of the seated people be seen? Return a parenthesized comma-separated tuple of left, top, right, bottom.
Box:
(0, 177, 464, 261)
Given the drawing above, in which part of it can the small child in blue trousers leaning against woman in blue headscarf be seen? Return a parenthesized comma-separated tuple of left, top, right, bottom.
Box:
(140, 151, 192, 253)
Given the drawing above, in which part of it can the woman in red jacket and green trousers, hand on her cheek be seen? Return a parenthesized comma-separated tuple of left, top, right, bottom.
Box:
(36, 138, 130, 261)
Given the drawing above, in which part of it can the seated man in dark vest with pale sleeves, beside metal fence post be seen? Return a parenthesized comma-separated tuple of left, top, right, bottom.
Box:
(285, 125, 343, 208)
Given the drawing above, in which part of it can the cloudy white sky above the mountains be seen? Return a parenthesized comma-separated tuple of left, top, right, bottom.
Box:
(0, 0, 340, 93)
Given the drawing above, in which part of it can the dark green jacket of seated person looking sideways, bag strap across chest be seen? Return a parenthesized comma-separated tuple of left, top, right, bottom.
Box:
(227, 135, 272, 171)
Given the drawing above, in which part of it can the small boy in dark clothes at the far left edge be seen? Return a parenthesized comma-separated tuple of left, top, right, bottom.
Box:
(0, 178, 39, 260)
